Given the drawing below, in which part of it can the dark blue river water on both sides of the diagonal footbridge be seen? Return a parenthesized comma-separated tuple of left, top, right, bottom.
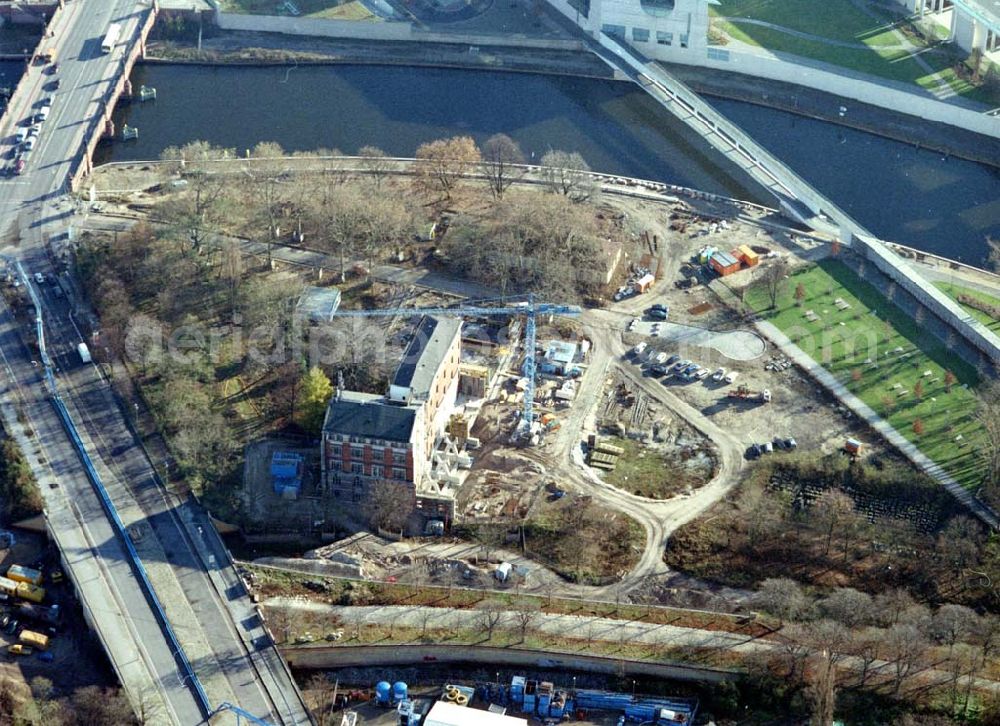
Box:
(0, 64, 1000, 264)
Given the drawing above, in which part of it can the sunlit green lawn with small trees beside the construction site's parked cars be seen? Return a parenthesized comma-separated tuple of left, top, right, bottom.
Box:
(747, 260, 982, 488)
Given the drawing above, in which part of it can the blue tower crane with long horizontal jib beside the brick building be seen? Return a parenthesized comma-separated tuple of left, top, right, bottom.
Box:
(334, 295, 582, 435)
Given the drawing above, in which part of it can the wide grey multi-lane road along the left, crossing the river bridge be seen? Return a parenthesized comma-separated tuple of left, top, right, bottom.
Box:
(0, 0, 310, 725)
